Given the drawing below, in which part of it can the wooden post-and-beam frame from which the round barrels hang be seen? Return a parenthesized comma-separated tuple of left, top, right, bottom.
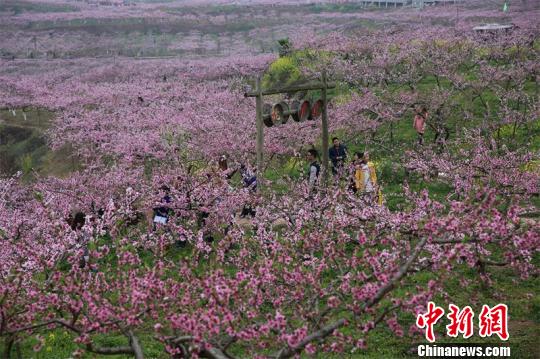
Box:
(244, 71, 336, 189)
